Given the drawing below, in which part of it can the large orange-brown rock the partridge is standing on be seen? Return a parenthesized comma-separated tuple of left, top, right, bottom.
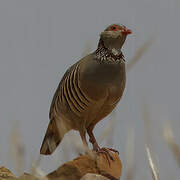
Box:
(47, 152, 122, 180)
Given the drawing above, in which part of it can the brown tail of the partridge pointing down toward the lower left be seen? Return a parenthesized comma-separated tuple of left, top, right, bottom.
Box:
(40, 119, 67, 155)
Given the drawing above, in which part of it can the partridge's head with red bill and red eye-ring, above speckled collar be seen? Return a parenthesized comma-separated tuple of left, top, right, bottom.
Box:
(100, 24, 132, 52)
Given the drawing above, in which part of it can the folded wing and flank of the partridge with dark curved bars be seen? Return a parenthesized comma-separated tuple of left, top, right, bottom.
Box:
(49, 61, 89, 120)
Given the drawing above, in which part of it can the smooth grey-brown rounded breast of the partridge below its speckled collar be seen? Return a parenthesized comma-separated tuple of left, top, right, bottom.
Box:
(80, 54, 125, 100)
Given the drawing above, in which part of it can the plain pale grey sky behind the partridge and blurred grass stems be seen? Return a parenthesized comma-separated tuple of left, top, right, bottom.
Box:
(0, 0, 180, 180)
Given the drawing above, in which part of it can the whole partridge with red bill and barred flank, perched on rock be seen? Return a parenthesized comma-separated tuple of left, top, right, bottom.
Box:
(40, 24, 132, 155)
